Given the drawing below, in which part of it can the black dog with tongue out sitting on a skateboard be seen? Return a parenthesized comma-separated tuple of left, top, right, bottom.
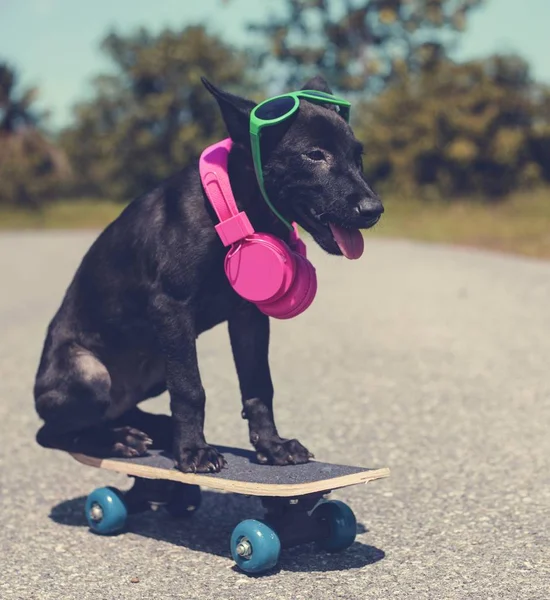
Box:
(34, 77, 383, 472)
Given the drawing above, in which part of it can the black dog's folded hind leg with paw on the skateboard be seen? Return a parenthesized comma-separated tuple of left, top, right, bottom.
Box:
(35, 346, 151, 457)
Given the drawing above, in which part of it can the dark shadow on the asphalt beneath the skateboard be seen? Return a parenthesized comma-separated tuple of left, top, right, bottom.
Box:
(50, 490, 385, 572)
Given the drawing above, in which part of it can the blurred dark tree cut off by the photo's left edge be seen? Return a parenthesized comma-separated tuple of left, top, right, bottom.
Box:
(0, 62, 70, 208)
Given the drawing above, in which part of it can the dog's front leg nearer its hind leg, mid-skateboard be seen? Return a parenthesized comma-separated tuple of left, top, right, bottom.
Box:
(152, 294, 225, 473)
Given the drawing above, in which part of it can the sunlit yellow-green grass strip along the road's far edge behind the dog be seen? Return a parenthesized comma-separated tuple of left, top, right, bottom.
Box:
(0, 190, 550, 258)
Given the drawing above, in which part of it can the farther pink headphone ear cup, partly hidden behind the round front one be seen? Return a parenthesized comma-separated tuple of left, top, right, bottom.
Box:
(257, 253, 317, 319)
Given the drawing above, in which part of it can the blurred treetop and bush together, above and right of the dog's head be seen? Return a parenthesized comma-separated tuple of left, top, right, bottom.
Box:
(251, 0, 550, 198)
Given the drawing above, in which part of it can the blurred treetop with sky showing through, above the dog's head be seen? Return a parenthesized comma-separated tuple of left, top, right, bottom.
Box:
(250, 0, 484, 93)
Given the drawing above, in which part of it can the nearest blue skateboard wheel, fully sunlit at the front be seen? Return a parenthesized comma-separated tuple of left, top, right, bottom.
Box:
(231, 519, 281, 573)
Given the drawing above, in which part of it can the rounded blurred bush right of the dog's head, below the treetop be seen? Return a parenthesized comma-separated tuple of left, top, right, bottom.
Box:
(356, 56, 549, 197)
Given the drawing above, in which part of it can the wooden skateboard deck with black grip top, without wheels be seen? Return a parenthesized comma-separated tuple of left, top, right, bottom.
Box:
(71, 446, 390, 498)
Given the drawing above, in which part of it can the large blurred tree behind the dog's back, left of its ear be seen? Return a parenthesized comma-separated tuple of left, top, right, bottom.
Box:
(62, 27, 256, 199)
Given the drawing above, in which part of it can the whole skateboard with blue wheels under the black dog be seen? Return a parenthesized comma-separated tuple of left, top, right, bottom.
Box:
(71, 446, 390, 573)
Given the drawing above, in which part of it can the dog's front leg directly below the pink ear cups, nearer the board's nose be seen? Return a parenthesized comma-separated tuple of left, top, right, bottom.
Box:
(229, 305, 313, 465)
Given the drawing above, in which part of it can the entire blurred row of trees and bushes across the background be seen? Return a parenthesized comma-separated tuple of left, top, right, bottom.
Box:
(0, 0, 550, 207)
